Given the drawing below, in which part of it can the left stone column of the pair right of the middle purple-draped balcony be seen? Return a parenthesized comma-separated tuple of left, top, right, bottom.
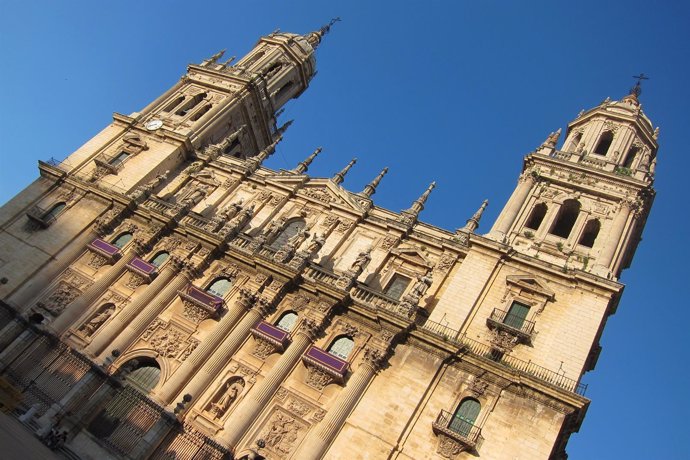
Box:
(157, 289, 256, 404)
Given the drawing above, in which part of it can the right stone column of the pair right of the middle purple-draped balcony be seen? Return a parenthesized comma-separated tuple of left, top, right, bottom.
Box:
(160, 298, 270, 399)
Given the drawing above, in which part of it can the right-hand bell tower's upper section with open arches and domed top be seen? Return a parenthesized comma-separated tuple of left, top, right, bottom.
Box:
(489, 82, 659, 279)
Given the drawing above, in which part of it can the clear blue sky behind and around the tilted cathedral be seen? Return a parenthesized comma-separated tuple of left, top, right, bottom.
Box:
(0, 0, 690, 460)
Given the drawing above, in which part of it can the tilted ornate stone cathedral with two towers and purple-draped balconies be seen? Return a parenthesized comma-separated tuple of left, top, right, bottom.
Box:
(0, 23, 658, 460)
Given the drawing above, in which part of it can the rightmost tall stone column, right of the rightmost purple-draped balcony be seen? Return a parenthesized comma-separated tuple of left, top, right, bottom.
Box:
(293, 347, 385, 460)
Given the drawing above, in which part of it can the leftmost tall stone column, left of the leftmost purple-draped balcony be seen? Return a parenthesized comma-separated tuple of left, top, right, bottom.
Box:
(7, 228, 98, 310)
